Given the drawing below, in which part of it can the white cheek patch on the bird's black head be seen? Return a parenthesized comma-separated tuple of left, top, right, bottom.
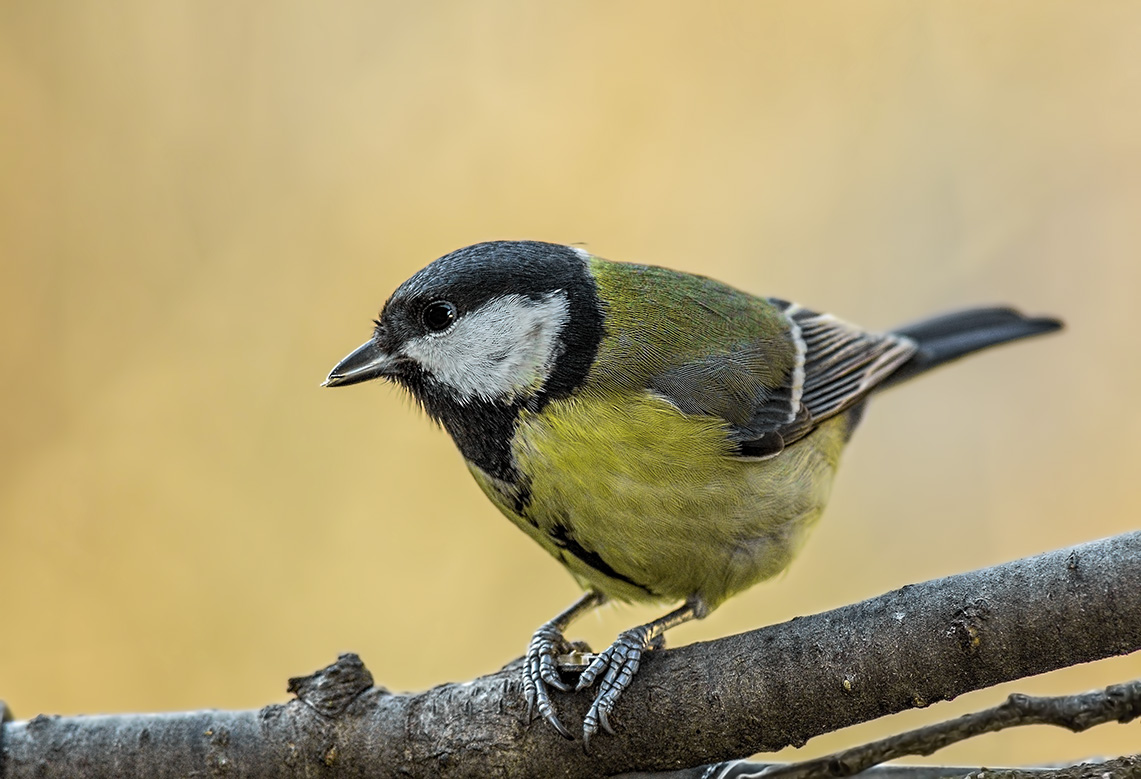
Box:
(404, 291, 571, 401)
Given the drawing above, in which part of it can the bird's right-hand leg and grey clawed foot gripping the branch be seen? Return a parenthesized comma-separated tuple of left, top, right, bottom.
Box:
(575, 598, 710, 745)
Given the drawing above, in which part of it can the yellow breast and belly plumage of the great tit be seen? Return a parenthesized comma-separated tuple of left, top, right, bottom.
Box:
(472, 395, 848, 608)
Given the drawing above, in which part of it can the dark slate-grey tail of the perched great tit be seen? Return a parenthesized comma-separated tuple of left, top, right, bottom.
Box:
(880, 308, 1062, 388)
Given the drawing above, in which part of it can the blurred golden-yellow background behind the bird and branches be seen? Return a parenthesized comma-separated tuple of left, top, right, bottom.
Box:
(0, 0, 1141, 764)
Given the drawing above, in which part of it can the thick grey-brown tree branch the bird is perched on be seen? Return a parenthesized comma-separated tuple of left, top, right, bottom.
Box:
(0, 531, 1141, 779)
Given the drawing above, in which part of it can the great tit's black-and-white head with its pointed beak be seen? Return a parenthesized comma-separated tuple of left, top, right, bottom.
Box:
(324, 241, 602, 419)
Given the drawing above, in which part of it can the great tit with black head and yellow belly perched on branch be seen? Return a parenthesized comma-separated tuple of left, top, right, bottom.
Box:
(325, 241, 1061, 741)
